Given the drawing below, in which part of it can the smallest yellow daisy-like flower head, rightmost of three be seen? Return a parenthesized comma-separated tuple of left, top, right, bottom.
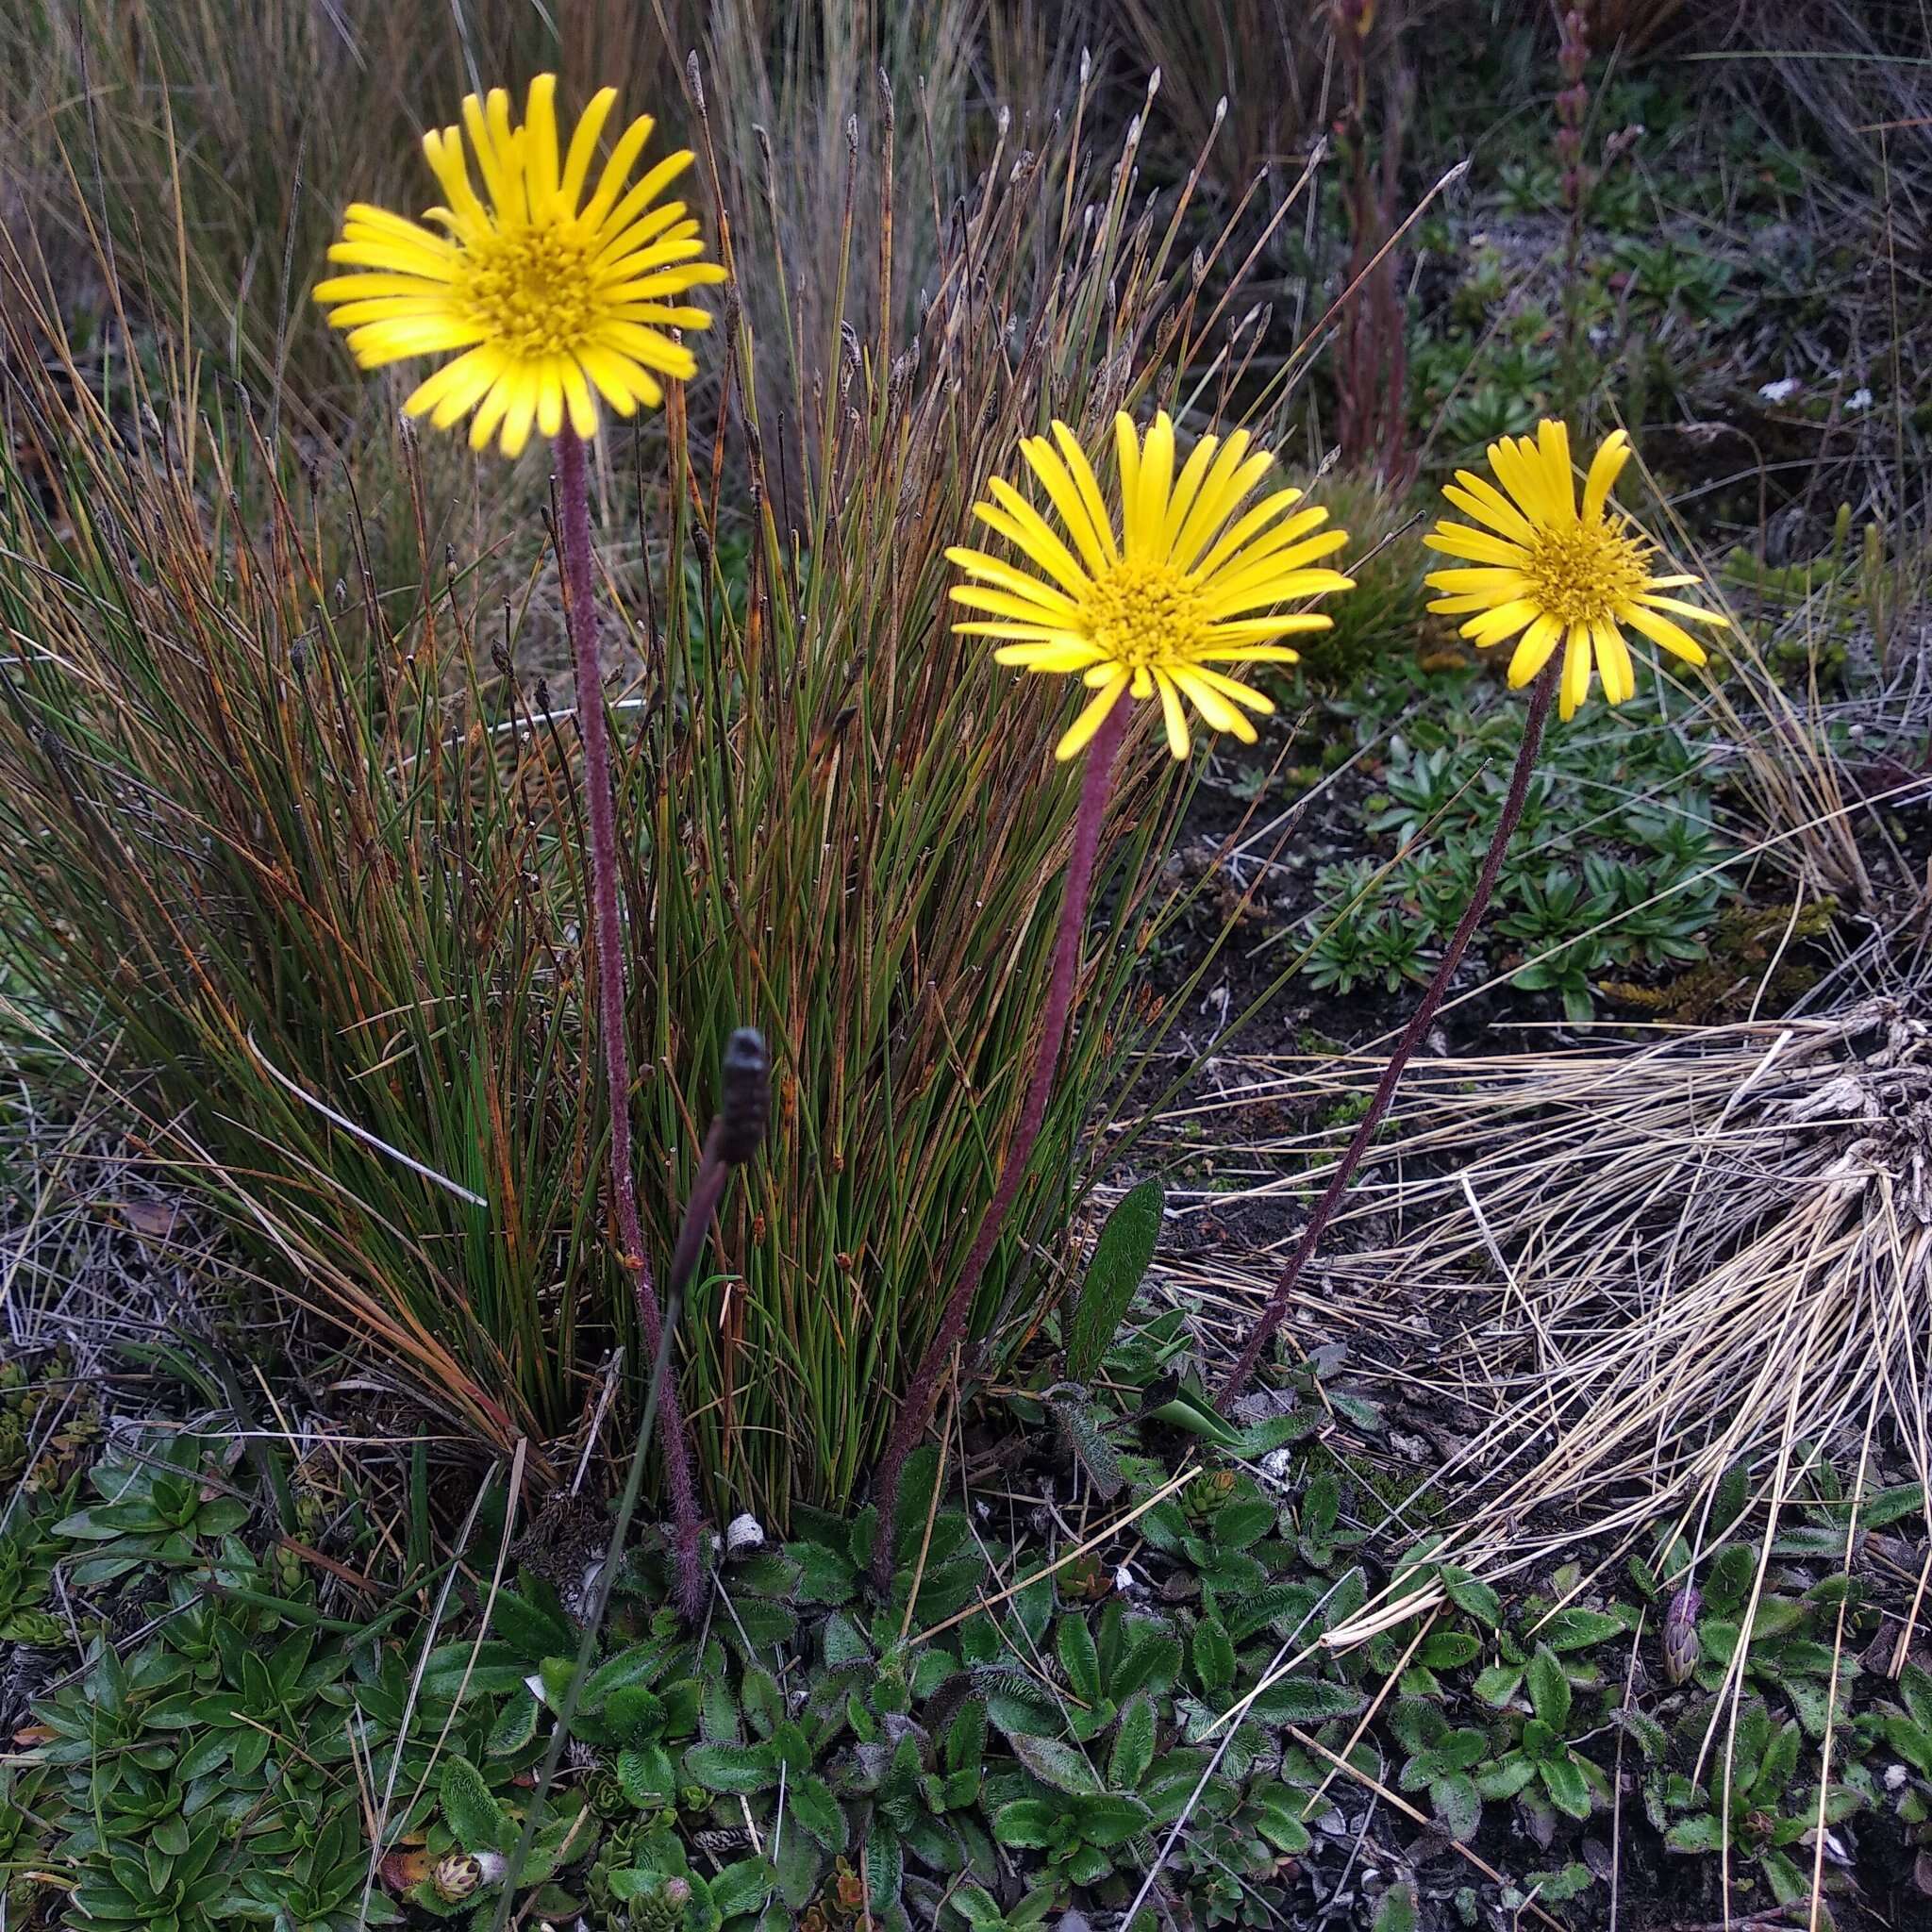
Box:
(1422, 421, 1727, 717)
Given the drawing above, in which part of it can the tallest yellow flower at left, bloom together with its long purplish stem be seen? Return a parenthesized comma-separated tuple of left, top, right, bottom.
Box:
(315, 74, 724, 1623)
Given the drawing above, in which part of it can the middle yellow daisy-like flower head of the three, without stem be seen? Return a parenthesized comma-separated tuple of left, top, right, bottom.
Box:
(947, 411, 1355, 759)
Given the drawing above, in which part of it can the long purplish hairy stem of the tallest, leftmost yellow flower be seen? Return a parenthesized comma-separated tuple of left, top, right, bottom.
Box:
(557, 419, 706, 1617)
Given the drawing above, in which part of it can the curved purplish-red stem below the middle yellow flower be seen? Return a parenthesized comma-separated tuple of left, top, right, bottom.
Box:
(872, 693, 1132, 1594)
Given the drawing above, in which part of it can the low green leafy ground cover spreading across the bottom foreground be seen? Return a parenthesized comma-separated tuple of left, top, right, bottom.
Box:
(0, 1267, 1932, 1932)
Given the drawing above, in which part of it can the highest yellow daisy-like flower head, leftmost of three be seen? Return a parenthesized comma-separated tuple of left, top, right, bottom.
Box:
(315, 74, 724, 456)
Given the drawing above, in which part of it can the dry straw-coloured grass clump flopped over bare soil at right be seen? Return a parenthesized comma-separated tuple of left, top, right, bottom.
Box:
(1362, 999, 1932, 1567)
